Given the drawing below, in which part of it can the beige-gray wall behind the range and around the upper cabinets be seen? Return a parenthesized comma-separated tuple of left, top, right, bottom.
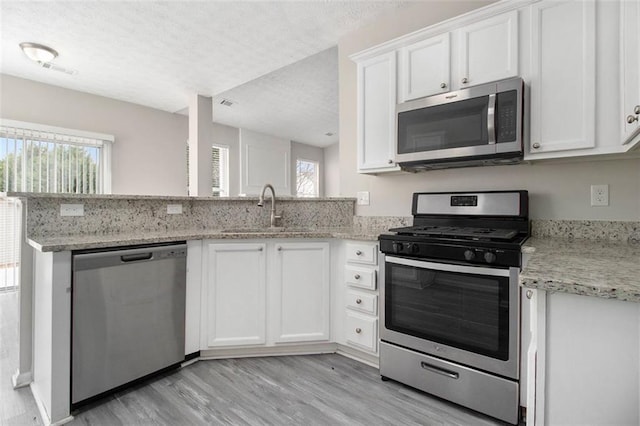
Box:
(338, 1, 640, 221)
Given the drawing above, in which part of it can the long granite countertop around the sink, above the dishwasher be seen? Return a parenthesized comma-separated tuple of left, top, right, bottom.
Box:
(28, 227, 380, 252)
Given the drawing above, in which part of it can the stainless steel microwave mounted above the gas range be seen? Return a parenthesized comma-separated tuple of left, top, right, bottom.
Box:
(395, 77, 524, 171)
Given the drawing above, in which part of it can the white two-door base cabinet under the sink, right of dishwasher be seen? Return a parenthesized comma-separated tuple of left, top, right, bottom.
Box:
(201, 240, 331, 350)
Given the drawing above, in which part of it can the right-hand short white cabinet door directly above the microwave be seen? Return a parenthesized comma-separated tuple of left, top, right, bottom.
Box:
(455, 10, 518, 87)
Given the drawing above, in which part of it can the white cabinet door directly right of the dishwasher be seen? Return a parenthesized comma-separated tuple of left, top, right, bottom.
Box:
(203, 243, 267, 348)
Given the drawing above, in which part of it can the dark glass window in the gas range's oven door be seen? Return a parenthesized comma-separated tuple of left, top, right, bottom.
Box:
(385, 262, 509, 360)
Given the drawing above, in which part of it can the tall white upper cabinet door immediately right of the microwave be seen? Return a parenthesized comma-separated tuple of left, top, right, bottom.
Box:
(529, 1, 596, 158)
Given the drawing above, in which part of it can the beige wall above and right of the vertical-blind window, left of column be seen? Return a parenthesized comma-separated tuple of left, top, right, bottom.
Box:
(0, 71, 188, 195)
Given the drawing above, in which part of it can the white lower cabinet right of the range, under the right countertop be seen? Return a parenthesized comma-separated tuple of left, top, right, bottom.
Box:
(522, 289, 640, 425)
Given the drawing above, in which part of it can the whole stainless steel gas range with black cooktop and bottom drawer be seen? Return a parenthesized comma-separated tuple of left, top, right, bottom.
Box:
(379, 191, 529, 424)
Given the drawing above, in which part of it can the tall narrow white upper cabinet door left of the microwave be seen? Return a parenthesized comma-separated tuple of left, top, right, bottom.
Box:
(358, 52, 399, 173)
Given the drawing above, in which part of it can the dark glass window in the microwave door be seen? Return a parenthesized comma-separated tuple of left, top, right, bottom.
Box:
(398, 96, 489, 154)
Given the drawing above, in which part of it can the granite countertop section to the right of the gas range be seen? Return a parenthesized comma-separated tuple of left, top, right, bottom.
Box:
(520, 238, 640, 302)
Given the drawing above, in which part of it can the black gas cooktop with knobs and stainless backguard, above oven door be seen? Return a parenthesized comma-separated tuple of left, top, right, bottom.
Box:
(379, 191, 529, 267)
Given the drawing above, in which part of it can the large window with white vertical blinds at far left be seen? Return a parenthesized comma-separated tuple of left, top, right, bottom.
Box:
(0, 120, 113, 194)
